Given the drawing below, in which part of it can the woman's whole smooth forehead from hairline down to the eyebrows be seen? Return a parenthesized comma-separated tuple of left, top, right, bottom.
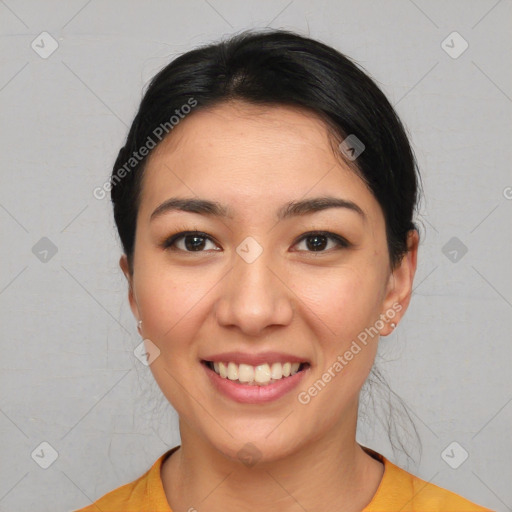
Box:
(139, 102, 379, 224)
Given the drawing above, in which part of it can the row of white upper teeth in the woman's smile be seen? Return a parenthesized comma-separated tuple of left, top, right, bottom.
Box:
(213, 361, 300, 384)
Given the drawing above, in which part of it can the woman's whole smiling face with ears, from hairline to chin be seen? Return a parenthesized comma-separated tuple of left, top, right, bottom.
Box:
(121, 102, 416, 460)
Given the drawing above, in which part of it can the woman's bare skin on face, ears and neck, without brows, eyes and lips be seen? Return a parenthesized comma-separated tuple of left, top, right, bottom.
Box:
(120, 101, 418, 512)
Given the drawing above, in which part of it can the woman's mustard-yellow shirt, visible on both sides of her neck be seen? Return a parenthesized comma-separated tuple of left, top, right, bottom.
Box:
(75, 446, 493, 512)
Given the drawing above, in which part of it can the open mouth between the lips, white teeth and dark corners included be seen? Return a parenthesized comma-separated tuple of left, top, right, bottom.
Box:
(201, 360, 310, 386)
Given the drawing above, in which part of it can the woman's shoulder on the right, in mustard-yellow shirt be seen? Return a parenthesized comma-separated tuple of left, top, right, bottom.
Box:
(363, 452, 493, 512)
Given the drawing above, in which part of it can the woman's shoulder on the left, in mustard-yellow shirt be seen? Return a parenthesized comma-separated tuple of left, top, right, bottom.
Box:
(74, 447, 178, 512)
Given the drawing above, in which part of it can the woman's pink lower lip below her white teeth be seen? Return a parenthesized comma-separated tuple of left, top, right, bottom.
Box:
(201, 363, 309, 404)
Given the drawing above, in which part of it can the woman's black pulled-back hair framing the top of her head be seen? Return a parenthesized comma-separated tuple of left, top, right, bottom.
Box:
(110, 30, 419, 271)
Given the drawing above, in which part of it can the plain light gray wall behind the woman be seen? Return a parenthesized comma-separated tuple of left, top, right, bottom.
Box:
(0, 0, 512, 512)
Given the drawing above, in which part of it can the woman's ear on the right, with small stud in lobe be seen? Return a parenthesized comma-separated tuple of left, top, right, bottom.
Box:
(380, 229, 419, 336)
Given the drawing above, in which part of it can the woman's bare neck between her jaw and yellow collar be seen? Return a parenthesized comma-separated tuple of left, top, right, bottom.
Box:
(162, 406, 384, 512)
